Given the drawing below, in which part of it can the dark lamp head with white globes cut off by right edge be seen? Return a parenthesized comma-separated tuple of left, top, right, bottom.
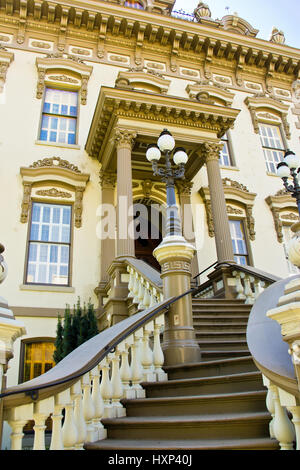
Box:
(277, 150, 300, 215)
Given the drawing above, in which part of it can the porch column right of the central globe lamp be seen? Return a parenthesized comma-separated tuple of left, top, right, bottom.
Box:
(202, 143, 234, 263)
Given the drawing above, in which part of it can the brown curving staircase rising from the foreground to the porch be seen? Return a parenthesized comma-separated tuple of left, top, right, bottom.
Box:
(85, 299, 279, 450)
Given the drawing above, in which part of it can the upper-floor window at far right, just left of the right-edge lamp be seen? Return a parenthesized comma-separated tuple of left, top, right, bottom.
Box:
(259, 124, 285, 173)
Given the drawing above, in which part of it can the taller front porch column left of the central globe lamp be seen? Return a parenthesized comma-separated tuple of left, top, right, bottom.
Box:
(115, 128, 136, 257)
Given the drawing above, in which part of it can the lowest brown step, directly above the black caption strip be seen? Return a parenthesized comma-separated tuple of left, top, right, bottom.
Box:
(84, 437, 279, 452)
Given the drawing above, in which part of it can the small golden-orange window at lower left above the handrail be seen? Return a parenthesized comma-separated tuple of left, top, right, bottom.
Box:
(23, 341, 55, 382)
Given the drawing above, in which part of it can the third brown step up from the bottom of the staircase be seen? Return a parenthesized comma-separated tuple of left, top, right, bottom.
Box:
(122, 390, 267, 417)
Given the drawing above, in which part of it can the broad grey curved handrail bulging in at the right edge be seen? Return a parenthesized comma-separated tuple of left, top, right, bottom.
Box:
(247, 275, 300, 397)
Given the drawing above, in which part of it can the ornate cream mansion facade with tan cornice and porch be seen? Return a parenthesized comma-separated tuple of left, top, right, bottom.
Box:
(0, 0, 300, 416)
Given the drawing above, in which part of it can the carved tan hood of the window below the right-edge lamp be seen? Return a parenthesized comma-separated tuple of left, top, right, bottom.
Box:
(265, 189, 299, 243)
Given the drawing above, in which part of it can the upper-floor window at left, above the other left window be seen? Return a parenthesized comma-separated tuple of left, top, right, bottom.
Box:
(40, 88, 78, 144)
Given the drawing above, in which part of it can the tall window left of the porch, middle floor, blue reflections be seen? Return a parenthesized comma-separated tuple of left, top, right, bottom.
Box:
(26, 202, 71, 285)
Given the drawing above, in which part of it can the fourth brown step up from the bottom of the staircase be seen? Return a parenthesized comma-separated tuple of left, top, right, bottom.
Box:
(143, 371, 264, 398)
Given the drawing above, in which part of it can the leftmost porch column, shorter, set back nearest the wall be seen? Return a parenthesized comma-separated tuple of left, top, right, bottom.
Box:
(99, 171, 117, 282)
